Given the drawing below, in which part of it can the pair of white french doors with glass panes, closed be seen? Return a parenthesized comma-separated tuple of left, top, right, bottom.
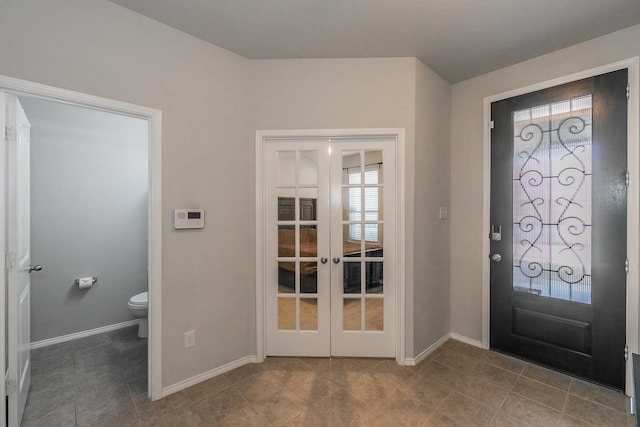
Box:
(264, 137, 397, 357)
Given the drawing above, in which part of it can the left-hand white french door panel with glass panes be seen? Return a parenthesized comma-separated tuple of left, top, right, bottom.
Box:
(265, 139, 331, 356)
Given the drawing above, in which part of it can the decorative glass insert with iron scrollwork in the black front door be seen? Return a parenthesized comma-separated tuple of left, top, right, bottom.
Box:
(513, 95, 592, 304)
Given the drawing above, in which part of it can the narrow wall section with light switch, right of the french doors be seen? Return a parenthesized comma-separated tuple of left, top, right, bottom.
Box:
(407, 61, 451, 356)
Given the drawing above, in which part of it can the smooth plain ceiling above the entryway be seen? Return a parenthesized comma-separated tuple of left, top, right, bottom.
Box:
(111, 0, 640, 83)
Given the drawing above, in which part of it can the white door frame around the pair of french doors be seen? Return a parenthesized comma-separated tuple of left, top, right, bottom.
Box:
(255, 129, 406, 365)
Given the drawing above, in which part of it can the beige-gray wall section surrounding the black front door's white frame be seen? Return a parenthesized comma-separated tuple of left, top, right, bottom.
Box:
(451, 26, 640, 341)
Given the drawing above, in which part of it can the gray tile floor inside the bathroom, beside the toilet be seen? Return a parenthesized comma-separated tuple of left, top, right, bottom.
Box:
(22, 326, 147, 427)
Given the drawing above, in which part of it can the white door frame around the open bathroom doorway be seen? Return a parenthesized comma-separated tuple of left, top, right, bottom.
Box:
(0, 75, 162, 406)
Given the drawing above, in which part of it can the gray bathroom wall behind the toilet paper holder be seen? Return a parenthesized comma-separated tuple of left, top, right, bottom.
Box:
(21, 97, 148, 341)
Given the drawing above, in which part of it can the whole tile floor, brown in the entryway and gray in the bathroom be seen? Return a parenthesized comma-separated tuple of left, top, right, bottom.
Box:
(23, 333, 635, 427)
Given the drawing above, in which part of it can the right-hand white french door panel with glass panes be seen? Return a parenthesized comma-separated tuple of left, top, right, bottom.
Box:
(331, 139, 396, 357)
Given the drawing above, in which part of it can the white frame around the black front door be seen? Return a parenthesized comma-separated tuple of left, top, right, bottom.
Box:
(482, 57, 640, 396)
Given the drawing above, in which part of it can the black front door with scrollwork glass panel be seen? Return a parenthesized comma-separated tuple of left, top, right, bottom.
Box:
(489, 70, 627, 389)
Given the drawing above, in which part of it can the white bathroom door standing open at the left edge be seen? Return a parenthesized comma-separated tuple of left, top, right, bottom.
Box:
(4, 93, 32, 426)
